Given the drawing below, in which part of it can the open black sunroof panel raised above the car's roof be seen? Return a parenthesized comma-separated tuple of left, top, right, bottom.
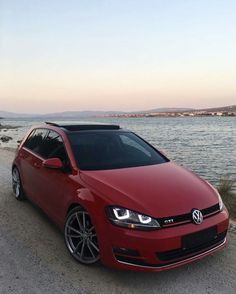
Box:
(45, 122, 121, 132)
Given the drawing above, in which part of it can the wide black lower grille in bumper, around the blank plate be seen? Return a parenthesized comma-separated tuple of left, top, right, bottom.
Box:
(156, 227, 227, 261)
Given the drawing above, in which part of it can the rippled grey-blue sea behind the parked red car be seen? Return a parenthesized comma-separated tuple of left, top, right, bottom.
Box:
(0, 117, 236, 184)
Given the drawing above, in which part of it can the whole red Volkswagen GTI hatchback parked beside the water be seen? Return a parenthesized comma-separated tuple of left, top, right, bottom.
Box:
(12, 123, 229, 271)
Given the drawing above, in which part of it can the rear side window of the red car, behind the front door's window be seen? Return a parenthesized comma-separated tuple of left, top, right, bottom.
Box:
(24, 129, 47, 154)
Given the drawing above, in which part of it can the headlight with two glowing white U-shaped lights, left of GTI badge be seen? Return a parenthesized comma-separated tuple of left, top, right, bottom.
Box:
(106, 206, 160, 230)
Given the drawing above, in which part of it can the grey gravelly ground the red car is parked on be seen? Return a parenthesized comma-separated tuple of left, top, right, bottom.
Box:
(0, 149, 236, 294)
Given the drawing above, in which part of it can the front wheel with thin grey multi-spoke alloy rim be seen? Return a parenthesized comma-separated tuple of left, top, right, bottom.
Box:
(64, 207, 100, 264)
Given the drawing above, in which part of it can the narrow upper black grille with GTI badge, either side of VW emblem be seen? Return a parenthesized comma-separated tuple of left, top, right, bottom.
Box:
(158, 204, 220, 227)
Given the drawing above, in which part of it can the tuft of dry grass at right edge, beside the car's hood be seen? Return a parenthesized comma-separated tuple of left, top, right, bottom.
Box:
(217, 178, 236, 220)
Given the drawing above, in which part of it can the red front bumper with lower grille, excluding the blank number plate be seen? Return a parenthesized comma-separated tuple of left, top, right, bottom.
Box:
(99, 209, 229, 271)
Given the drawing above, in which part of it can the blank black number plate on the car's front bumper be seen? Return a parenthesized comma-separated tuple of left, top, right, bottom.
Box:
(182, 226, 217, 249)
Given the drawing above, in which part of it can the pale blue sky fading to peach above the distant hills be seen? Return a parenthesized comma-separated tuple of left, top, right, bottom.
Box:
(0, 0, 236, 113)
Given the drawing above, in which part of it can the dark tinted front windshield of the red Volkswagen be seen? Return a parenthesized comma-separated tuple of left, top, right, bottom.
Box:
(69, 131, 168, 170)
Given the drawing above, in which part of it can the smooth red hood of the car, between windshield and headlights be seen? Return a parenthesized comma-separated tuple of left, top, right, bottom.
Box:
(81, 162, 218, 217)
